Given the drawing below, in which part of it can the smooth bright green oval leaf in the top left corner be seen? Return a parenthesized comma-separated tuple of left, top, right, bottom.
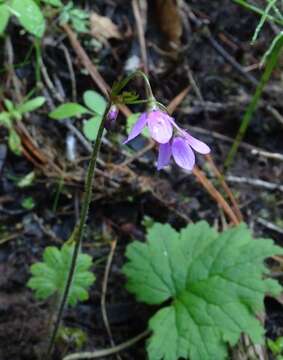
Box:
(10, 0, 45, 37)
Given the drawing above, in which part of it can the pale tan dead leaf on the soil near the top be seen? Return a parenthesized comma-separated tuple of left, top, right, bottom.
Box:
(90, 12, 122, 43)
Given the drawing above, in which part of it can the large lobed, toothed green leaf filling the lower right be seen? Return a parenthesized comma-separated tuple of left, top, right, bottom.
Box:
(123, 221, 283, 360)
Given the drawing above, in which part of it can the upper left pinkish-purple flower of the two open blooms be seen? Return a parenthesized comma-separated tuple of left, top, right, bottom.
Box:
(124, 110, 174, 144)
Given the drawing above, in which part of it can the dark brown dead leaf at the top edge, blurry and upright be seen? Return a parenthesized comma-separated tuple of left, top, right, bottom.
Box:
(155, 0, 182, 49)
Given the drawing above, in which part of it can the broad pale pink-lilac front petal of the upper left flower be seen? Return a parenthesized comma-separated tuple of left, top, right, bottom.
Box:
(147, 110, 173, 144)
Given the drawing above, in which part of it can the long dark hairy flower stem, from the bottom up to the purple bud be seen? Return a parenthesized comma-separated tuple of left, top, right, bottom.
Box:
(47, 104, 110, 359)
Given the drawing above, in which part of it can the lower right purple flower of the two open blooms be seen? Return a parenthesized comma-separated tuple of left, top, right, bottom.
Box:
(157, 132, 210, 170)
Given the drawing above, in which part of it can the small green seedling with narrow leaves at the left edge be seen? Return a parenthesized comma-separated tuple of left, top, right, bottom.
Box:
(0, 96, 45, 155)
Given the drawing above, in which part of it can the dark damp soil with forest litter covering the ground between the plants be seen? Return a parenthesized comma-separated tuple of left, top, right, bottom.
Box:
(0, 0, 283, 360)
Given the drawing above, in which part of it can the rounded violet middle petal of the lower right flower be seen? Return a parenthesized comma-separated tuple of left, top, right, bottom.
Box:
(172, 137, 195, 170)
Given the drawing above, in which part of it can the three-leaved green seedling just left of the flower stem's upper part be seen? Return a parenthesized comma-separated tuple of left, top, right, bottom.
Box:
(49, 90, 107, 141)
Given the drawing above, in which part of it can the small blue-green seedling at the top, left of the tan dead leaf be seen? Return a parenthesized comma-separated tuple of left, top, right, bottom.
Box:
(59, 1, 89, 33)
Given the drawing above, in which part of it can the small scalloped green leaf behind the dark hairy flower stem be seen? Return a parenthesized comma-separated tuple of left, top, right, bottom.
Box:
(27, 244, 95, 305)
